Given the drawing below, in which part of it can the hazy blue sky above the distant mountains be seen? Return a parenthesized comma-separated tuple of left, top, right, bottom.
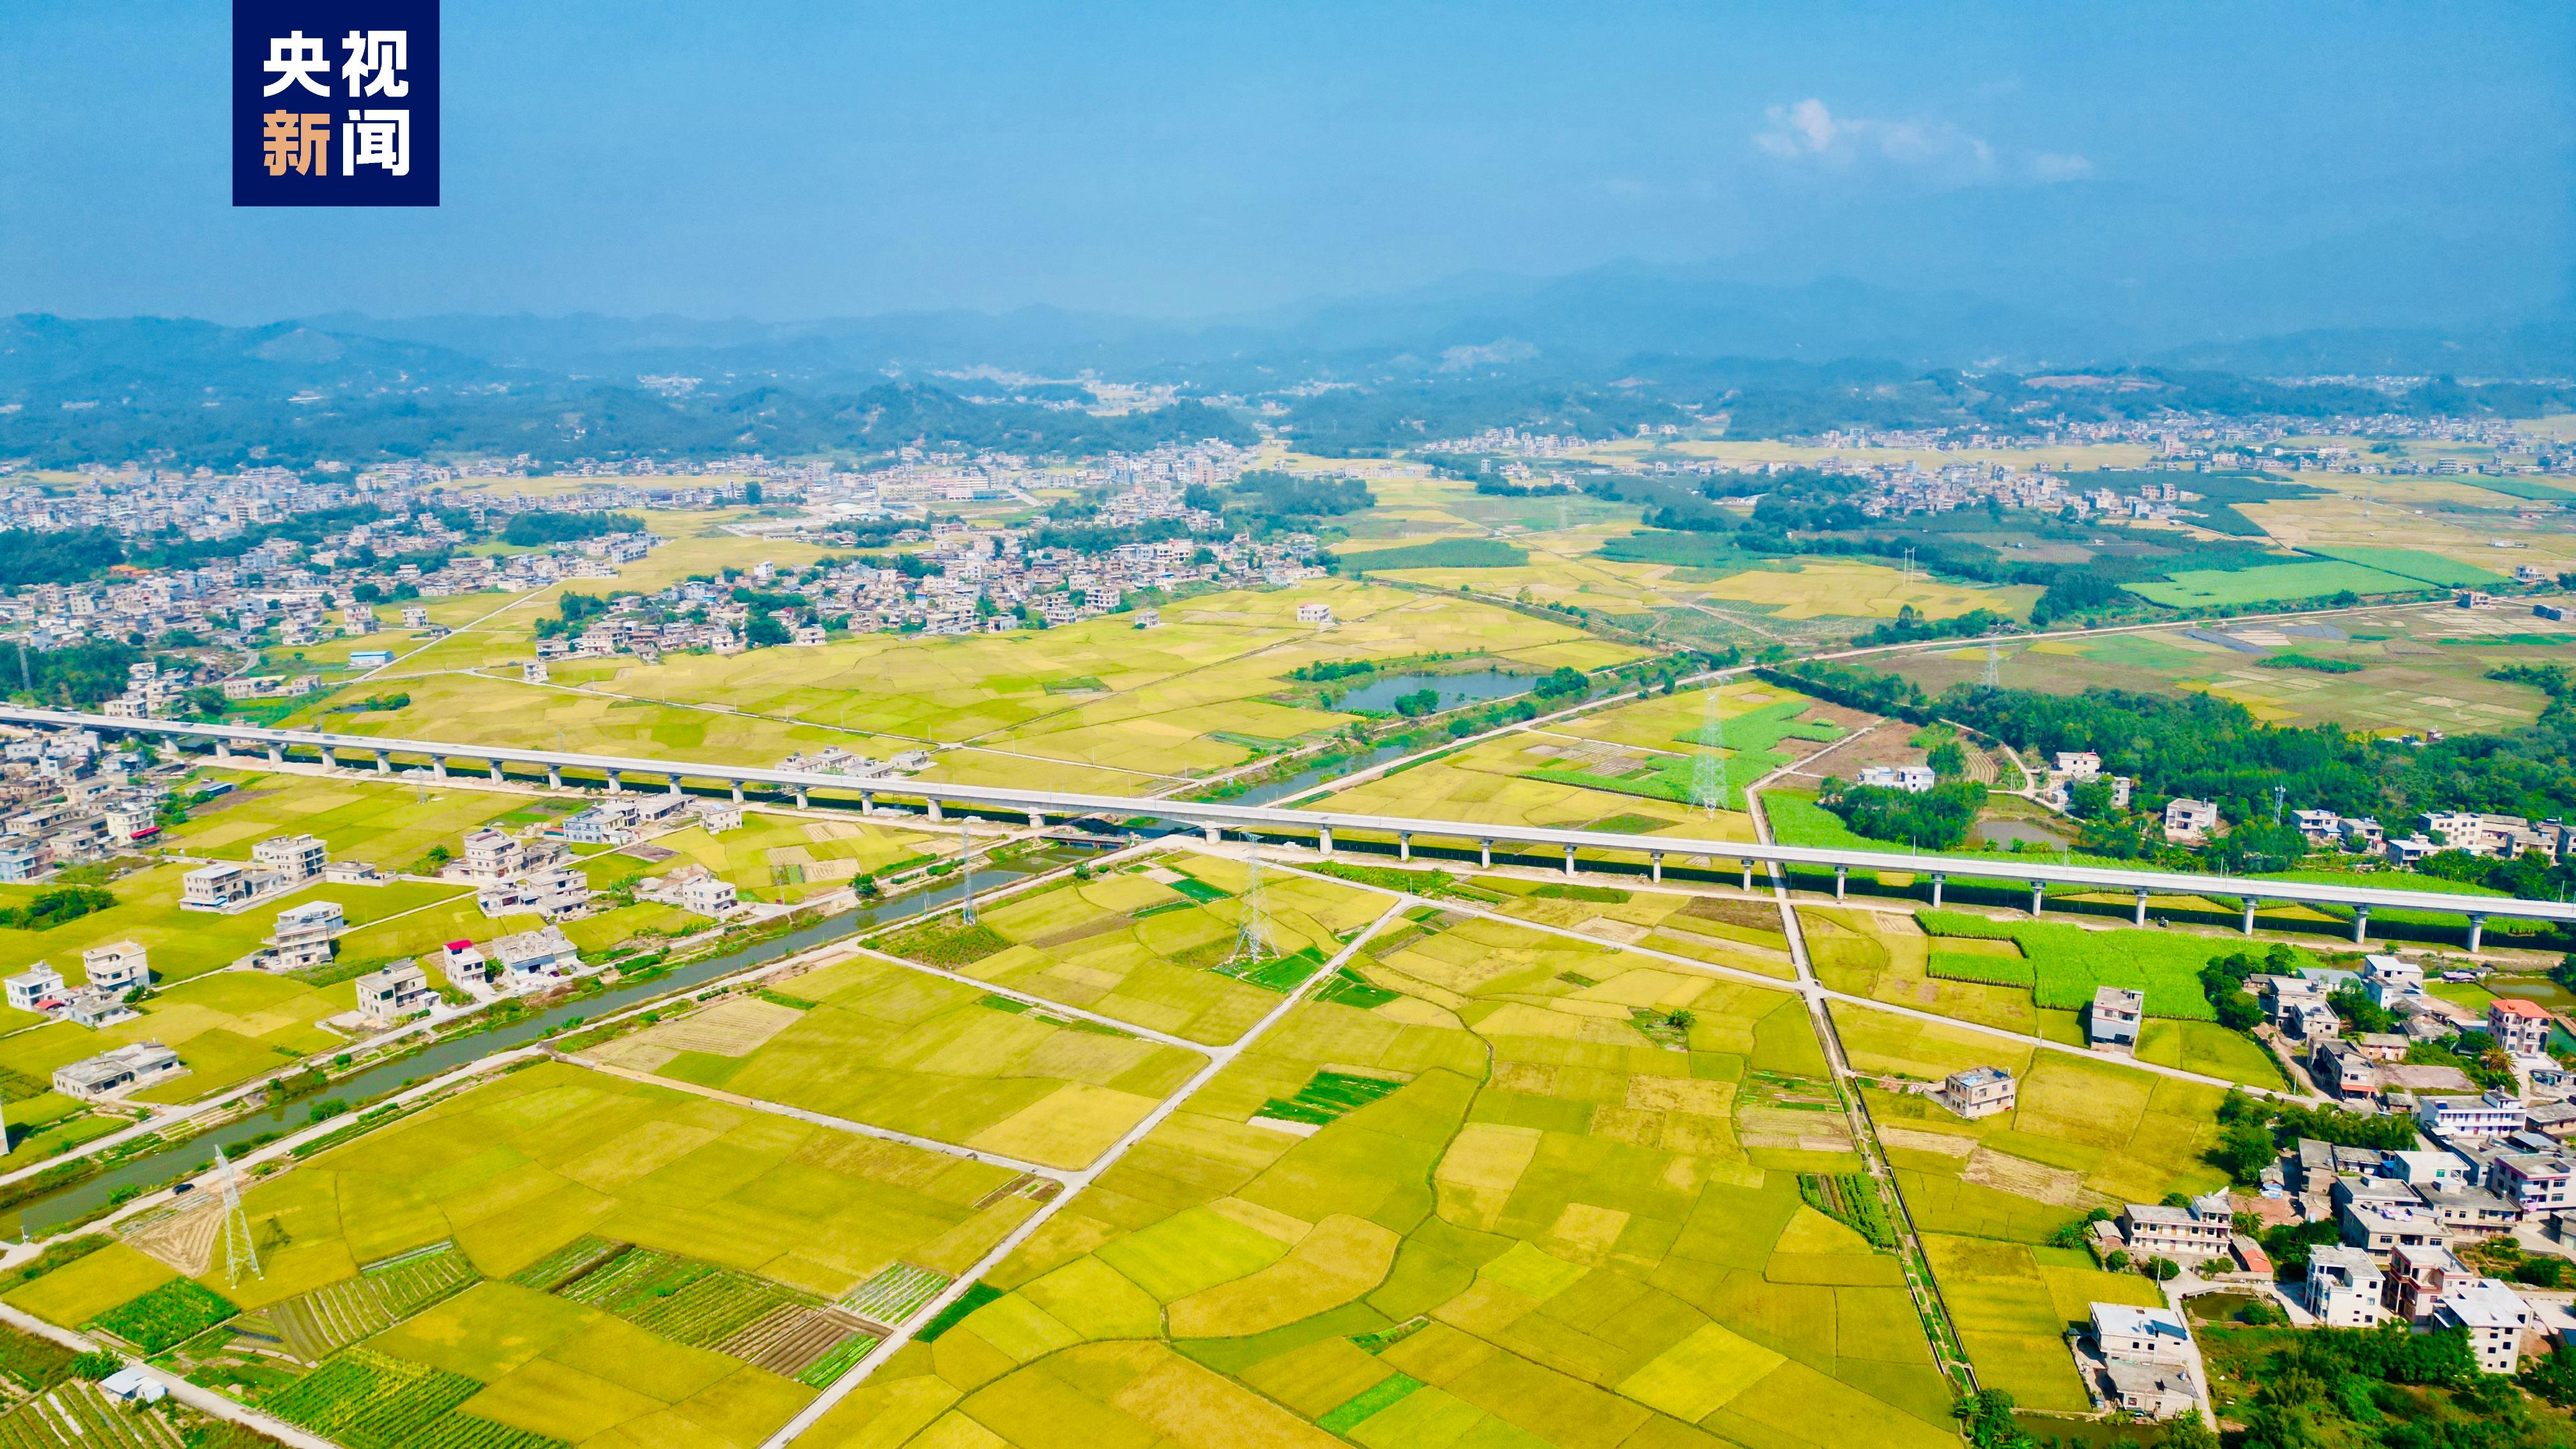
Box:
(0, 0, 2576, 322)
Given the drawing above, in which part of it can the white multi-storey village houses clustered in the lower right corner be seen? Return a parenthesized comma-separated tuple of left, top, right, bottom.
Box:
(1926, 954, 2576, 1418)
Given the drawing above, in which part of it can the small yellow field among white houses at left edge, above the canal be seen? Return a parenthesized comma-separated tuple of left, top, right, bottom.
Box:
(0, 962, 358, 1103)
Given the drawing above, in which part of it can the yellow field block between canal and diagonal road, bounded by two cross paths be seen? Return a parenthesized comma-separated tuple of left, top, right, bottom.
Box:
(595, 944, 1200, 1168)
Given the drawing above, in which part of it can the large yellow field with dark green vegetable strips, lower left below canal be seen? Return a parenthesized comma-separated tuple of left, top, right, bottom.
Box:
(8, 1062, 1061, 1449)
